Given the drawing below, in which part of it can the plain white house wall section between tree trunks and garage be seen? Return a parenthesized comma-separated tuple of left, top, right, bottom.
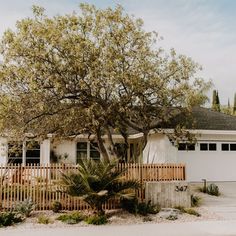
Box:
(143, 134, 177, 163)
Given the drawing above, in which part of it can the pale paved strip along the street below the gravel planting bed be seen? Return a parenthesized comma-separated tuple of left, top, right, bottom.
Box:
(0, 220, 236, 236)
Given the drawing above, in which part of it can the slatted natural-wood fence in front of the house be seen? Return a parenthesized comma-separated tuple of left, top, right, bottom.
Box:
(0, 164, 185, 210)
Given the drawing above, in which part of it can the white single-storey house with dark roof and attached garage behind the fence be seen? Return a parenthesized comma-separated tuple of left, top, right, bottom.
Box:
(0, 107, 236, 182)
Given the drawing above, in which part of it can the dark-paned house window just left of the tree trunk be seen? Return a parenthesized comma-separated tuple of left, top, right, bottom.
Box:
(76, 142, 100, 162)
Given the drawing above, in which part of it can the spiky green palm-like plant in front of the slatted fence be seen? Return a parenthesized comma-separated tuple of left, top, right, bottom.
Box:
(62, 160, 140, 215)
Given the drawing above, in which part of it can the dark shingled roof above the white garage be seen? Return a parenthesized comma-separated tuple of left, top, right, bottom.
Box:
(168, 107, 236, 130)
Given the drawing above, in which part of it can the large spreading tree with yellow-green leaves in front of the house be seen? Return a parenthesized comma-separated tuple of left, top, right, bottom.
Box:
(0, 4, 209, 160)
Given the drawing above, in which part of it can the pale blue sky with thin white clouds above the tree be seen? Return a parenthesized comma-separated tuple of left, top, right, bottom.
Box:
(0, 0, 236, 104)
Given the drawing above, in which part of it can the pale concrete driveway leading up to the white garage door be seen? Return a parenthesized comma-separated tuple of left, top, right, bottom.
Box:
(197, 182, 236, 219)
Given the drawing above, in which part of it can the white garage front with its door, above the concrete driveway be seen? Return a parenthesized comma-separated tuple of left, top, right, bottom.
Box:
(177, 134, 236, 182)
